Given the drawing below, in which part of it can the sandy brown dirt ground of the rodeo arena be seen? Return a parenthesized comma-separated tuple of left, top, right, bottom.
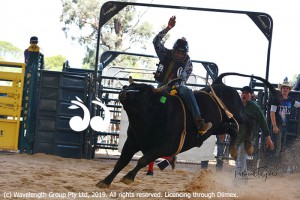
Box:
(0, 152, 300, 200)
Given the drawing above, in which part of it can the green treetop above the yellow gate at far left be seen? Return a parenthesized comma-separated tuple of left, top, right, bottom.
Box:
(0, 41, 23, 62)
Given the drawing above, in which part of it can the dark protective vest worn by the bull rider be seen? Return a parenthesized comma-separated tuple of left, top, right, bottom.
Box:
(154, 51, 189, 84)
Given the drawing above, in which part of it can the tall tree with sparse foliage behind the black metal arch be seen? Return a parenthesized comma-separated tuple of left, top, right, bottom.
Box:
(60, 0, 153, 68)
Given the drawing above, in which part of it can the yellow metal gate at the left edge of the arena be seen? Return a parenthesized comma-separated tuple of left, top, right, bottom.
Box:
(0, 62, 25, 150)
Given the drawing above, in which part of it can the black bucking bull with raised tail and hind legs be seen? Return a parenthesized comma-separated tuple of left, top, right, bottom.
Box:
(96, 73, 275, 188)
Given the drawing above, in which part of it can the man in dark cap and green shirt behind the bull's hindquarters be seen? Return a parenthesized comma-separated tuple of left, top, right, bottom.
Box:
(236, 86, 274, 177)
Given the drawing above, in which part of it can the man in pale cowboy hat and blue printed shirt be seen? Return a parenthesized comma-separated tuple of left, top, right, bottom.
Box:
(270, 77, 300, 157)
